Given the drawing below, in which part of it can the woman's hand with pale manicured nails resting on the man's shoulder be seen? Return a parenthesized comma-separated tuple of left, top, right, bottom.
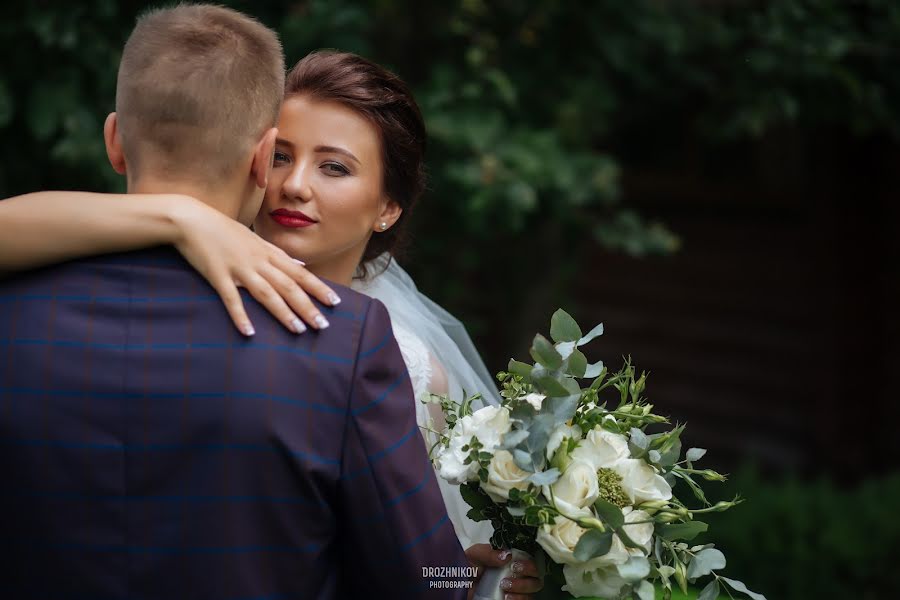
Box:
(172, 198, 340, 335)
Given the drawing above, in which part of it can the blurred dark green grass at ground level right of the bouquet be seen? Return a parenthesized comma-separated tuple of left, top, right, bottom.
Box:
(701, 468, 900, 600)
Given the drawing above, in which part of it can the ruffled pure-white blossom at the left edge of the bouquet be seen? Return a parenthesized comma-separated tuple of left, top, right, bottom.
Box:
(437, 406, 510, 485)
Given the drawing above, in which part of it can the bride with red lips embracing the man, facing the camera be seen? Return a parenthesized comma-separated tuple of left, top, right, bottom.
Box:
(0, 52, 541, 599)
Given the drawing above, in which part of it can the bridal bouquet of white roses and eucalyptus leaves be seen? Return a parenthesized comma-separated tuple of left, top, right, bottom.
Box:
(427, 310, 765, 600)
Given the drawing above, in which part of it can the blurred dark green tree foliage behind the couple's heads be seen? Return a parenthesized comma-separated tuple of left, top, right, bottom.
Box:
(0, 0, 900, 333)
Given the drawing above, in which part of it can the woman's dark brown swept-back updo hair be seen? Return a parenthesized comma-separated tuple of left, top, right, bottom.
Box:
(284, 50, 426, 279)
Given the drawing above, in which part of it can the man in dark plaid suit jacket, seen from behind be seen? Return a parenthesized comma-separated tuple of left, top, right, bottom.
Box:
(0, 5, 468, 600)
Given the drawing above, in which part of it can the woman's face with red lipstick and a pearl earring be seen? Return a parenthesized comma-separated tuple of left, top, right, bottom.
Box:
(254, 96, 400, 285)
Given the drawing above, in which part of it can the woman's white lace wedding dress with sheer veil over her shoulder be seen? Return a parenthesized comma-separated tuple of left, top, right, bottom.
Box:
(353, 256, 499, 548)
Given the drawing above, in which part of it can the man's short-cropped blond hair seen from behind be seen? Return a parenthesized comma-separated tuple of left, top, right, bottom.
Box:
(116, 4, 284, 180)
